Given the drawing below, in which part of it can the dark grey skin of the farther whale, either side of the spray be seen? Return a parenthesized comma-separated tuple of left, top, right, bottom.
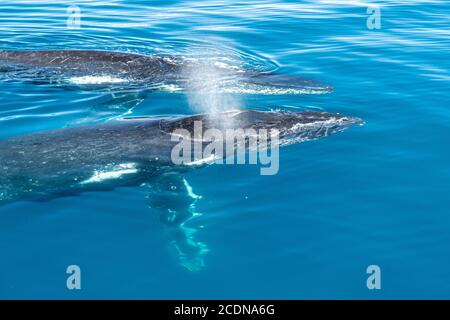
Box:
(0, 50, 333, 94)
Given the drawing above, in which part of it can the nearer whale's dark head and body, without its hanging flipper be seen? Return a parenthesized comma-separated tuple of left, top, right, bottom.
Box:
(0, 110, 361, 203)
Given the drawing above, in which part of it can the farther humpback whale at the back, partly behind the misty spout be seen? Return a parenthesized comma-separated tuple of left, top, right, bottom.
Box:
(0, 50, 333, 94)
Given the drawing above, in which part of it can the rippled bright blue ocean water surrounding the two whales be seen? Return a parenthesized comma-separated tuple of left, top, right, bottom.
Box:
(0, 0, 450, 299)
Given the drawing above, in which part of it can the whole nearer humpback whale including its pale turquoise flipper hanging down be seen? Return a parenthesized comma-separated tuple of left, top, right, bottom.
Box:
(0, 110, 362, 271)
